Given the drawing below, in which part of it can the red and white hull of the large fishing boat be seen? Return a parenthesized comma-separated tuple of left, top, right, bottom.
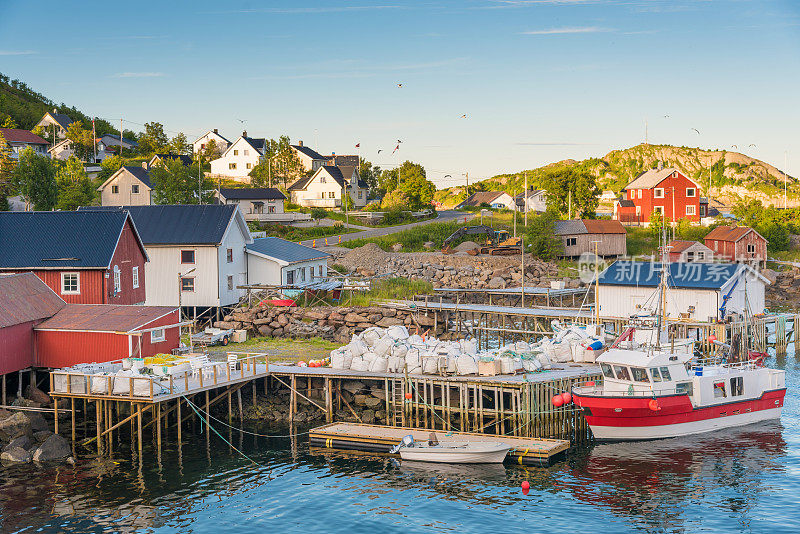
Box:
(573, 388, 786, 441)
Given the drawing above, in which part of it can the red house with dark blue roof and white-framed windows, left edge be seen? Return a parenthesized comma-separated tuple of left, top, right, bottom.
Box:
(0, 211, 148, 304)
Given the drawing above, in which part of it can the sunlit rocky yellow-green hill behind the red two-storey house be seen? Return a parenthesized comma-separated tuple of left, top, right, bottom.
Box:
(435, 144, 800, 207)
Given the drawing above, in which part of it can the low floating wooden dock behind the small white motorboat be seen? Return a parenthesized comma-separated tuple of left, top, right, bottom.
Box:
(309, 423, 570, 466)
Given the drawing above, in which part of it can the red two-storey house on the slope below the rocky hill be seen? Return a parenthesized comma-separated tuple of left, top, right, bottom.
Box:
(614, 168, 708, 224)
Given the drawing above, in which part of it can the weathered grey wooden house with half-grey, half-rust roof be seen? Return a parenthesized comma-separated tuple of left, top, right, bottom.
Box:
(555, 219, 628, 258)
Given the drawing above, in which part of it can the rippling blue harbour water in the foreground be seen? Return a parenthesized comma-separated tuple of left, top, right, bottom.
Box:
(0, 356, 800, 534)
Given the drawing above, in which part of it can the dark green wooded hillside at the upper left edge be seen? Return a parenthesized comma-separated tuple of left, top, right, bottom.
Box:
(0, 73, 118, 135)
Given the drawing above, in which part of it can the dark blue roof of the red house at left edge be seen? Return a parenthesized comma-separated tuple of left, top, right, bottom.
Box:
(0, 210, 133, 269)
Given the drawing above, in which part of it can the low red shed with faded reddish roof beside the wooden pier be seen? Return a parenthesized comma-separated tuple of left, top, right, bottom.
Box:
(35, 304, 180, 368)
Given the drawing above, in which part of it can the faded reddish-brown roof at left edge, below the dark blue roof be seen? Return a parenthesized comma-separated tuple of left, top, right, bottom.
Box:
(0, 273, 66, 328)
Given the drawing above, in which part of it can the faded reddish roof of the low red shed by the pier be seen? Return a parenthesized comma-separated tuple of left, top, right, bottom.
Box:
(36, 304, 177, 332)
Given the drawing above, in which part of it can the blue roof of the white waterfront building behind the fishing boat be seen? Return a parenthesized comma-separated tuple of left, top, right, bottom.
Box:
(599, 261, 746, 289)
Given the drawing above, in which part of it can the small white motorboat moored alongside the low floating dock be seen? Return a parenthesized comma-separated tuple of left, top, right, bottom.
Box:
(392, 433, 511, 464)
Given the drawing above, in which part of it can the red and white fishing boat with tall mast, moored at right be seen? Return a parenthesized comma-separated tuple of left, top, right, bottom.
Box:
(572, 228, 786, 441)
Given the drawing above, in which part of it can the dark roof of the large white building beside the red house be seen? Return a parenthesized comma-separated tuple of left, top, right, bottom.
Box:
(81, 204, 244, 245)
